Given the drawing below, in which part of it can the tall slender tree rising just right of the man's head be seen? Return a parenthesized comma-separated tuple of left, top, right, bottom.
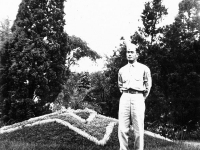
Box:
(131, 0, 168, 127)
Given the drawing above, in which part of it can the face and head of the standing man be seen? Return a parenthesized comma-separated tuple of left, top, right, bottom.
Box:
(126, 44, 138, 61)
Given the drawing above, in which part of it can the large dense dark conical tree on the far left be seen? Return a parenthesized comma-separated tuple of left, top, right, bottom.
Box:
(1, 0, 70, 124)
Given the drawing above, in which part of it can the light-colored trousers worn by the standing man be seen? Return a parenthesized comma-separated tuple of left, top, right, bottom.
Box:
(118, 93, 145, 150)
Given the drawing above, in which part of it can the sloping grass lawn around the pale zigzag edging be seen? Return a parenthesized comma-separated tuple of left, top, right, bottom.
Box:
(0, 110, 200, 150)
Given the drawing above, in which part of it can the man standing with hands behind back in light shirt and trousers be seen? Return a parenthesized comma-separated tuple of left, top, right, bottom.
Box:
(118, 43, 152, 150)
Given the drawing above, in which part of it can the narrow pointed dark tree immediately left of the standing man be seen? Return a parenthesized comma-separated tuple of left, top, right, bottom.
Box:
(95, 37, 127, 118)
